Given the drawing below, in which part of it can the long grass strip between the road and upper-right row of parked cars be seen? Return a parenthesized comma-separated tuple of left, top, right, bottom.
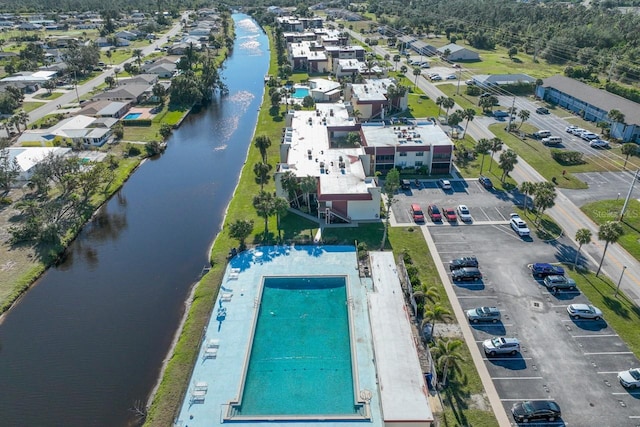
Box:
(489, 123, 602, 189)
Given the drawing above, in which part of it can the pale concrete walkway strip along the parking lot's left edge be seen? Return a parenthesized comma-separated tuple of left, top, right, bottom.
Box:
(420, 226, 511, 427)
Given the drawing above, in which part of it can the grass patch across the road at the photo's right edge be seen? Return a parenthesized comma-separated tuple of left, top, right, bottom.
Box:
(580, 198, 640, 261)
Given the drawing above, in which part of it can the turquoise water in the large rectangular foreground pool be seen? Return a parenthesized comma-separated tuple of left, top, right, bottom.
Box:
(238, 277, 358, 416)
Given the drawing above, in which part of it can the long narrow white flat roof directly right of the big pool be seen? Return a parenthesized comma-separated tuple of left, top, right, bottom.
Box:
(369, 252, 433, 423)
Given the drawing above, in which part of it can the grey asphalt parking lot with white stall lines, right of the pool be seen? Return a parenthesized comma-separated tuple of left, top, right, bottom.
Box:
(426, 222, 640, 426)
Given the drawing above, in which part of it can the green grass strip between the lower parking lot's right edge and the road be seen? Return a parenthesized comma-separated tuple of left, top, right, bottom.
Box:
(571, 268, 640, 357)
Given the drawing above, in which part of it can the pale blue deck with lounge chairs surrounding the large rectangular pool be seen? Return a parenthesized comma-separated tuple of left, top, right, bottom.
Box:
(174, 246, 384, 427)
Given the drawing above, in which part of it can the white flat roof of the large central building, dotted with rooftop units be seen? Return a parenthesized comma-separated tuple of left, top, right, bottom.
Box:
(284, 103, 376, 194)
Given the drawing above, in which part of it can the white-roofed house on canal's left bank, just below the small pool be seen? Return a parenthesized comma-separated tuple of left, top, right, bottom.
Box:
(18, 115, 118, 147)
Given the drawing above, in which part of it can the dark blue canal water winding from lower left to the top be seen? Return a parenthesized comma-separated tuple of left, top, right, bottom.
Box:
(0, 14, 269, 427)
